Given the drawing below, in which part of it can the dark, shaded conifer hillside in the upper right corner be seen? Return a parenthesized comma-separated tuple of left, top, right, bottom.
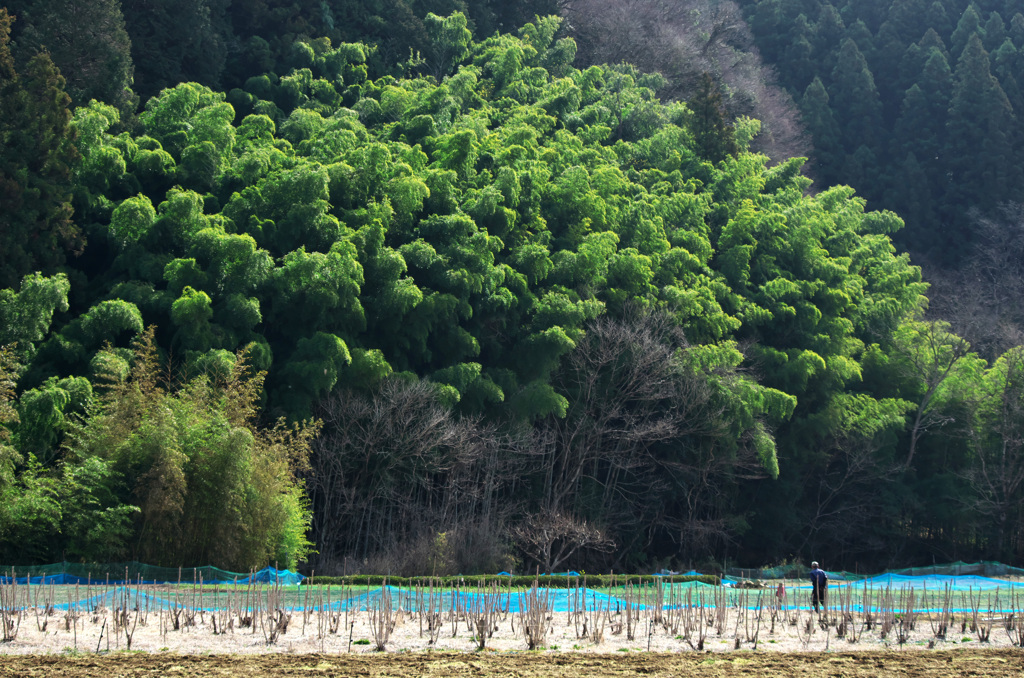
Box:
(740, 0, 1024, 350)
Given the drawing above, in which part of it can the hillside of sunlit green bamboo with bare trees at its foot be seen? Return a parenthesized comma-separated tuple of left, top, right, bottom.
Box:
(0, 0, 1024, 574)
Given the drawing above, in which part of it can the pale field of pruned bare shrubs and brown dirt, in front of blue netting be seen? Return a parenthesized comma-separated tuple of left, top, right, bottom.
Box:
(0, 587, 1024, 678)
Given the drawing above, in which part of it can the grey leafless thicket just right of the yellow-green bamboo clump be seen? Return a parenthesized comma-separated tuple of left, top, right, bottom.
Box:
(308, 380, 525, 574)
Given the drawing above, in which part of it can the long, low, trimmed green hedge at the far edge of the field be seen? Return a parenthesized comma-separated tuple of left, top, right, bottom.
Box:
(302, 575, 722, 589)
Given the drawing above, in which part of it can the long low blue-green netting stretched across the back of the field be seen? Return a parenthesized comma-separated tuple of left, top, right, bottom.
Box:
(14, 576, 1024, 613)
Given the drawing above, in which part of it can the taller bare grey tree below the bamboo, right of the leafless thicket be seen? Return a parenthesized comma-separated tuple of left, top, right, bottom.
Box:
(537, 311, 765, 568)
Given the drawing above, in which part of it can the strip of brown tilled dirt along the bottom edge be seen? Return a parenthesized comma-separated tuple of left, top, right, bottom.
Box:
(0, 649, 1024, 678)
